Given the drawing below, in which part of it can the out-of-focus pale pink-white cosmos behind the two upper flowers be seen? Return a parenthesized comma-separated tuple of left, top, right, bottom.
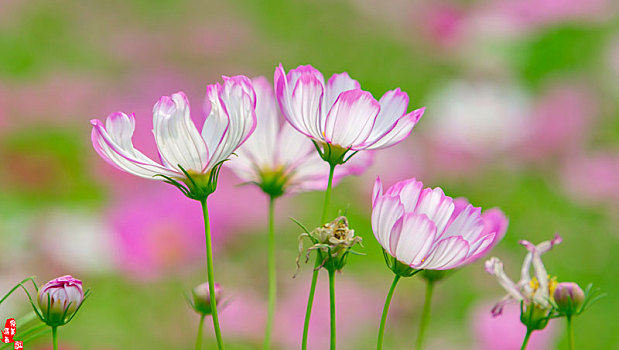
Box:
(226, 77, 371, 196)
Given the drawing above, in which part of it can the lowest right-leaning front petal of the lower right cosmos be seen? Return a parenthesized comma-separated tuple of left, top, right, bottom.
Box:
(413, 236, 469, 270)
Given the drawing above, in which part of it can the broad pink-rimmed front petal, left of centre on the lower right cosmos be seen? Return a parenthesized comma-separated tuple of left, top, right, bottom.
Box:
(391, 213, 436, 266)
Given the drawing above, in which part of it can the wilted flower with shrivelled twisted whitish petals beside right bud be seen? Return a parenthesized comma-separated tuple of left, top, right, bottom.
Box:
(486, 235, 561, 323)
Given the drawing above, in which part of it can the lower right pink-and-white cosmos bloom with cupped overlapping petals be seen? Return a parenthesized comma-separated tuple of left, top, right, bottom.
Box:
(372, 178, 508, 270)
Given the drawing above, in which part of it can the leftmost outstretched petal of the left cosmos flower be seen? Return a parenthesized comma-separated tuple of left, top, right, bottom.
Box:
(90, 113, 179, 179)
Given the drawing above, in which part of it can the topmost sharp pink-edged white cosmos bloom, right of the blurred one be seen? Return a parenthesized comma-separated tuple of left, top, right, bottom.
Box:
(275, 64, 424, 151)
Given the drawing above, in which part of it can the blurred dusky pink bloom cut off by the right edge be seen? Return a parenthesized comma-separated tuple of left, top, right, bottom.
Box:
(561, 152, 619, 203)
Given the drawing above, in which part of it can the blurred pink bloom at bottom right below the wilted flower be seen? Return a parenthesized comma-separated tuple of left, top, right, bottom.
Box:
(471, 304, 555, 350)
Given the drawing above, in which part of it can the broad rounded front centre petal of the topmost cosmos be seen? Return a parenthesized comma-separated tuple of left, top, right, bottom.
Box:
(324, 90, 380, 149)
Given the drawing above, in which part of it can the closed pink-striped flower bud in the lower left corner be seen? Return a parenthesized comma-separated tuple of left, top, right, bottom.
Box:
(38, 275, 84, 327)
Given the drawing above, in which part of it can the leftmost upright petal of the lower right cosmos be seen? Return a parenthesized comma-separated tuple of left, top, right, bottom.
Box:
(372, 196, 404, 253)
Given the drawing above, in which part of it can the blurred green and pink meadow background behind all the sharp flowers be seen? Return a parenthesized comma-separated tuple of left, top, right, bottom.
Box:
(0, 0, 619, 350)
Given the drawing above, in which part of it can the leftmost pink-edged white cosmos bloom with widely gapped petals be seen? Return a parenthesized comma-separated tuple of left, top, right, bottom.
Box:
(91, 76, 256, 180)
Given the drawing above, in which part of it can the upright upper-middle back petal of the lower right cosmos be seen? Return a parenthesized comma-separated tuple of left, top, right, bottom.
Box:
(415, 187, 454, 236)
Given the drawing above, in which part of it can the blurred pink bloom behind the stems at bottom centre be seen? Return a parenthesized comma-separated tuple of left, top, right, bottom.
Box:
(275, 276, 383, 349)
